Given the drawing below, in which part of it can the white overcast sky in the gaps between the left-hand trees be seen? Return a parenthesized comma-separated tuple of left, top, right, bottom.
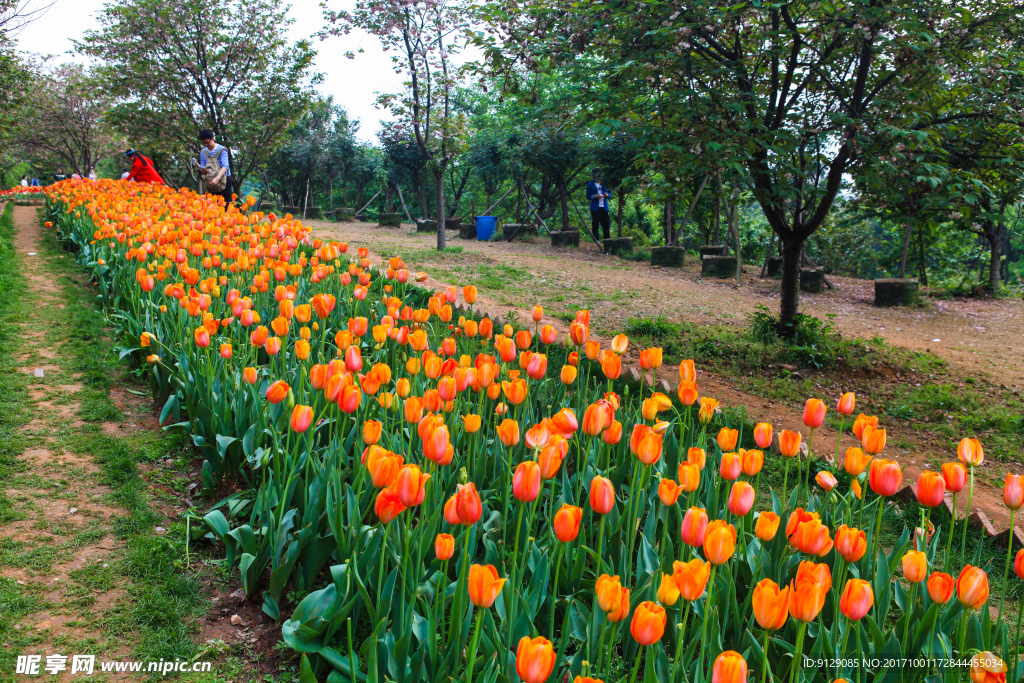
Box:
(17, 0, 401, 141)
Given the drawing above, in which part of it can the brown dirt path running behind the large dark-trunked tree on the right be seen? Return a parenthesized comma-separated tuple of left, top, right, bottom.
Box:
(310, 221, 1024, 388)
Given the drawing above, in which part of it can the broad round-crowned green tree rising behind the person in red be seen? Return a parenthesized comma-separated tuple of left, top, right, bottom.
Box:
(76, 0, 318, 193)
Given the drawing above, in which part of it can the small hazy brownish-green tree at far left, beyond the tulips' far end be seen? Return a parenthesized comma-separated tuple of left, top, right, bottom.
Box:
(17, 62, 120, 177)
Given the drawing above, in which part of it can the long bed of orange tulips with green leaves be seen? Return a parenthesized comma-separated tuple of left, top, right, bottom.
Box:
(36, 181, 1024, 683)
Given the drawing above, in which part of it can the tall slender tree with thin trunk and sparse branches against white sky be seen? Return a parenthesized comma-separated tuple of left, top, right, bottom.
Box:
(326, 0, 468, 250)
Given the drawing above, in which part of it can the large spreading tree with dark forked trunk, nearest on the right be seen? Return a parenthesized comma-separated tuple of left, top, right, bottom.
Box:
(478, 0, 1024, 336)
